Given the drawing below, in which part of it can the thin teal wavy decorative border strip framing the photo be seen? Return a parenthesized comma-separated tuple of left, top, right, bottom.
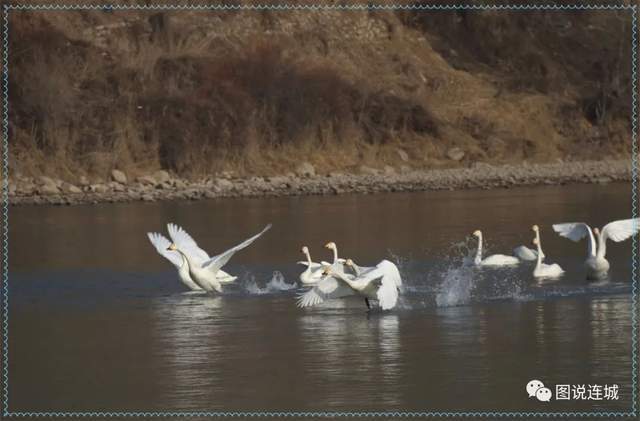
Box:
(0, 2, 640, 418)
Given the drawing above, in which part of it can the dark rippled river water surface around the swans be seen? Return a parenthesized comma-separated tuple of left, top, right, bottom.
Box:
(9, 184, 632, 411)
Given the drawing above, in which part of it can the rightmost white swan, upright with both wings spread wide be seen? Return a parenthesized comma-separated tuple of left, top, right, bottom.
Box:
(553, 218, 640, 280)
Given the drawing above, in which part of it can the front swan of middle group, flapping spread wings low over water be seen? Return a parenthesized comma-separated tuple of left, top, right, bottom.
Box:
(298, 260, 402, 310)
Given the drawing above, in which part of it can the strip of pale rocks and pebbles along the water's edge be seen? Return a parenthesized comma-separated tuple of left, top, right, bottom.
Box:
(9, 160, 631, 205)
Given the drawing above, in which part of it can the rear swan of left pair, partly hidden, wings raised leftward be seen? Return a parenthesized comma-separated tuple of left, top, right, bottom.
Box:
(147, 224, 236, 291)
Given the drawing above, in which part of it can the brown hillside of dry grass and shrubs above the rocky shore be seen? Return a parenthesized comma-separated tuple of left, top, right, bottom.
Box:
(9, 2, 631, 178)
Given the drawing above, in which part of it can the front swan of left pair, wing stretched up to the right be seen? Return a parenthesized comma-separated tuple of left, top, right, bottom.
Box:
(167, 224, 271, 292)
